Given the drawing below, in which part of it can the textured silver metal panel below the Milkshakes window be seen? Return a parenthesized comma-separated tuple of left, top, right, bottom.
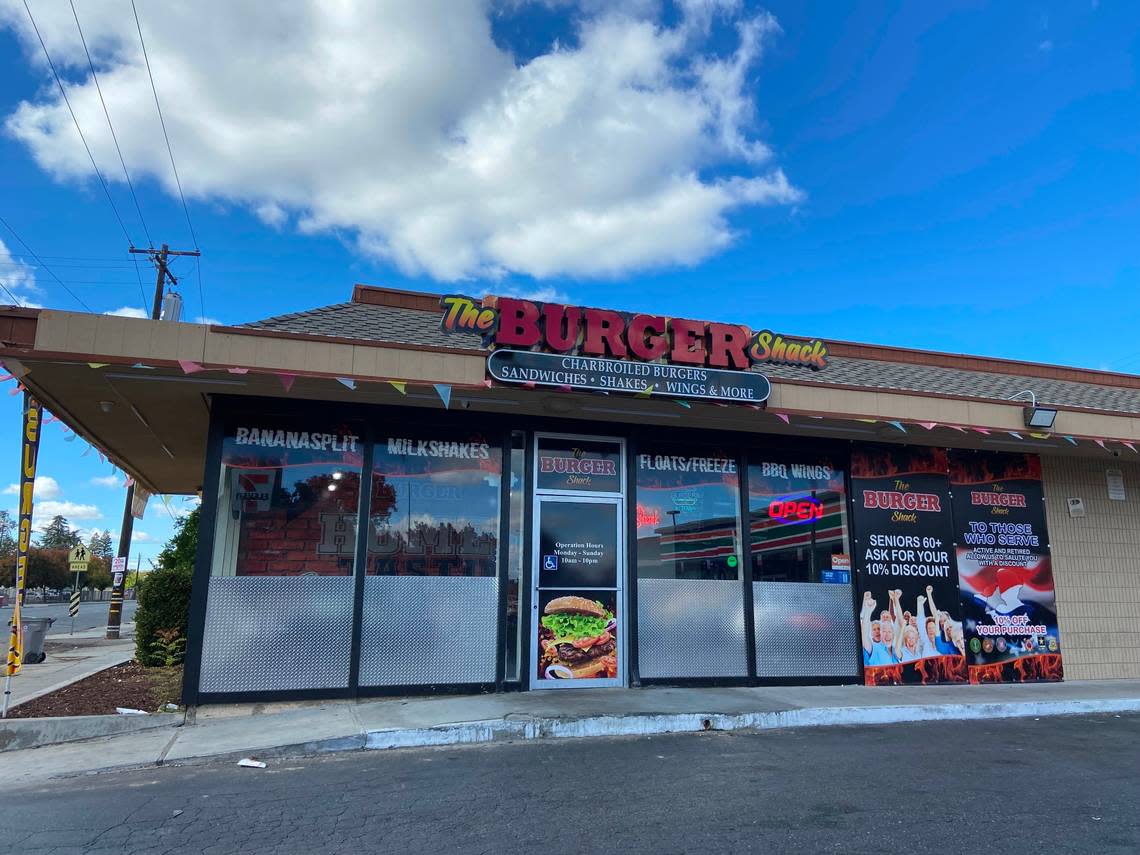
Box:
(360, 576, 498, 686)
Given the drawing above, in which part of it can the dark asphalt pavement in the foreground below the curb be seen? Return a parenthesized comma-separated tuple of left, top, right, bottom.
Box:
(0, 715, 1140, 855)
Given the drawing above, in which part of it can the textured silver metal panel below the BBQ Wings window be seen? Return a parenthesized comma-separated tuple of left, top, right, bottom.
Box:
(752, 581, 860, 677)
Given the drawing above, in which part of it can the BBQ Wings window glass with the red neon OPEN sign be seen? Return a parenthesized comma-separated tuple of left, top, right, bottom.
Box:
(748, 458, 850, 584)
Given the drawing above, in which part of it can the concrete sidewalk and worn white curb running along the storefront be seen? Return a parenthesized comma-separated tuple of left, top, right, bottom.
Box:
(0, 681, 1140, 785)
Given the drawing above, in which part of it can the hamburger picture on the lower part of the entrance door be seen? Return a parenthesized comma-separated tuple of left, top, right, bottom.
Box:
(538, 596, 618, 679)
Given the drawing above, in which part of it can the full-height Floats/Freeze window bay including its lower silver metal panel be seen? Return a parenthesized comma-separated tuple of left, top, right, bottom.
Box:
(636, 446, 748, 678)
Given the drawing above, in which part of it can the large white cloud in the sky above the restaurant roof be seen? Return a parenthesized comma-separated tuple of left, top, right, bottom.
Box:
(0, 0, 801, 281)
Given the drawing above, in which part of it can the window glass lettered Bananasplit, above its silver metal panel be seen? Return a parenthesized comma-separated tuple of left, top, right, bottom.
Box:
(212, 420, 363, 576)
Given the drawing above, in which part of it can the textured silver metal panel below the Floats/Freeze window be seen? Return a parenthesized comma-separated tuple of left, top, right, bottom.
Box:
(637, 579, 748, 678)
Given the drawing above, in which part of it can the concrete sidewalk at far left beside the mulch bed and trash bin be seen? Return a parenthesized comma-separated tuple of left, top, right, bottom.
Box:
(2, 624, 135, 707)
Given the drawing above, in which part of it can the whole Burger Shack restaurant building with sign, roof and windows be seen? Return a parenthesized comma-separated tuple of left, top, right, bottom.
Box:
(5, 287, 1140, 703)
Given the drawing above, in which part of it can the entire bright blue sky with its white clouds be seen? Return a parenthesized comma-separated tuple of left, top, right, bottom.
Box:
(0, 0, 1140, 555)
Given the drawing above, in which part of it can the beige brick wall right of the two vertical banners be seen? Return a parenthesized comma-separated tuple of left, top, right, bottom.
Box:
(1042, 451, 1140, 679)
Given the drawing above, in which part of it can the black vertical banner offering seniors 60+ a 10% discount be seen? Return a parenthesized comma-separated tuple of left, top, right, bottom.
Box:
(852, 446, 966, 685)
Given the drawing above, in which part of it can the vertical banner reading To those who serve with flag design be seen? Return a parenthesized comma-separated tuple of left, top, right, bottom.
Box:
(950, 451, 1061, 683)
